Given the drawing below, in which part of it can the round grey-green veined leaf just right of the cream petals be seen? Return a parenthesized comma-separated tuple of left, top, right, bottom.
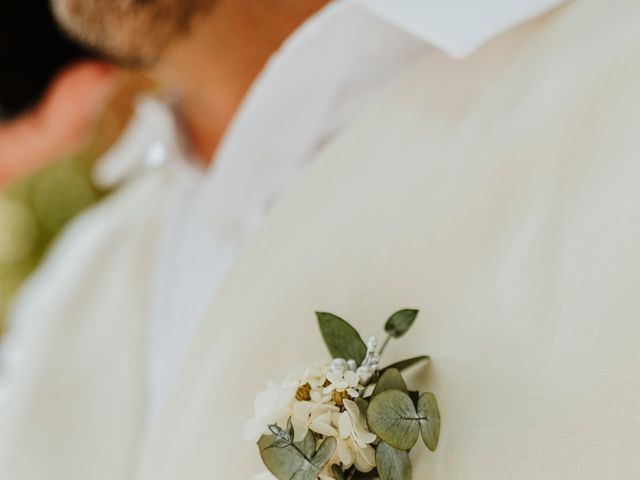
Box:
(367, 390, 420, 450)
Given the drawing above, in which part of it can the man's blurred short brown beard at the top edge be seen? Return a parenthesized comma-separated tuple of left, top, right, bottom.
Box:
(50, 0, 215, 68)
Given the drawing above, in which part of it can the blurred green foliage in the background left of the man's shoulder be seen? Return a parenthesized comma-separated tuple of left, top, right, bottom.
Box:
(0, 74, 153, 331)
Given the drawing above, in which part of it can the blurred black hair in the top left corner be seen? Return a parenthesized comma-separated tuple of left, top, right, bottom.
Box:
(0, 0, 95, 120)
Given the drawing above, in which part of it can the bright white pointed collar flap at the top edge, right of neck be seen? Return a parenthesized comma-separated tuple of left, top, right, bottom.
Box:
(354, 0, 566, 58)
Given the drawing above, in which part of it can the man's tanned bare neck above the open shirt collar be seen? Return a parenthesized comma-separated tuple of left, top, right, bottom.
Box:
(154, 0, 328, 163)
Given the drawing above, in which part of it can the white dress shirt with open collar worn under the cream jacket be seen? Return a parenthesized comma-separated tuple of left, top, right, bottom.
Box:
(8, 0, 560, 428)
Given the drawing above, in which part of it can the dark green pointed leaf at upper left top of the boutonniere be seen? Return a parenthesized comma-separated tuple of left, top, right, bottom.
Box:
(316, 312, 367, 365)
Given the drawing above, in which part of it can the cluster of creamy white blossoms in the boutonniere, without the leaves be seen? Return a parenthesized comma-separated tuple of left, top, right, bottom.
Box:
(245, 359, 376, 480)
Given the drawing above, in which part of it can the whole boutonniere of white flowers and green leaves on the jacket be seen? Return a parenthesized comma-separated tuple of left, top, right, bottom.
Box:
(245, 310, 440, 480)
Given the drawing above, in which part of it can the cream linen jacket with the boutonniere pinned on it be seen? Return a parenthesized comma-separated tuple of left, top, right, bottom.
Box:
(0, 0, 640, 480)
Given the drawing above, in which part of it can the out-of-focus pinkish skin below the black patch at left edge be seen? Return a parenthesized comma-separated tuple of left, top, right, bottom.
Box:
(0, 62, 119, 188)
